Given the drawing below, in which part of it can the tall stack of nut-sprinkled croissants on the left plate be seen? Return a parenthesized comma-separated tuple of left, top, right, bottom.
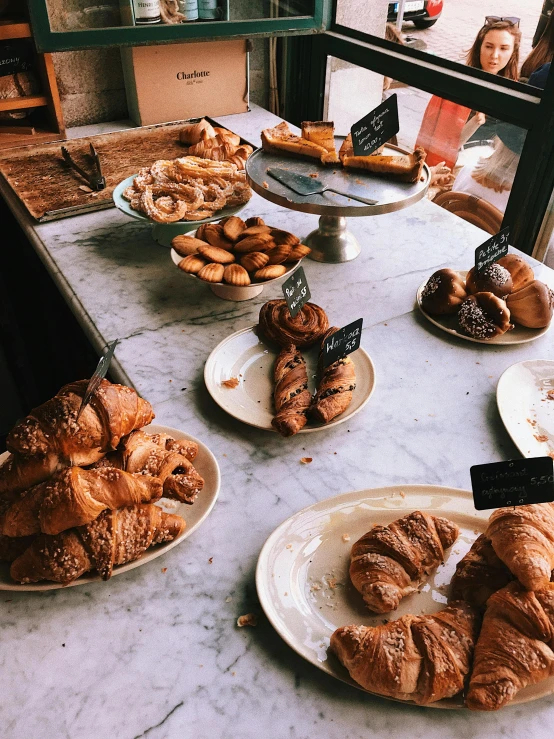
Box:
(0, 380, 204, 585)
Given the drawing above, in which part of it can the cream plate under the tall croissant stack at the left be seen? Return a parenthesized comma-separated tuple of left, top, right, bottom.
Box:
(0, 424, 221, 591)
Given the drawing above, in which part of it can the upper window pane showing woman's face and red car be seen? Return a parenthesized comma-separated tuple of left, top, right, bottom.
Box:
(336, 0, 554, 81)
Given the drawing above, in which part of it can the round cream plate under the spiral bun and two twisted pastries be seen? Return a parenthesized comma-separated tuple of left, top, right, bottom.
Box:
(204, 326, 375, 434)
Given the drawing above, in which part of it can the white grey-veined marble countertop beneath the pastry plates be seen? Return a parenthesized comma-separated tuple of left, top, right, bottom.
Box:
(0, 109, 554, 739)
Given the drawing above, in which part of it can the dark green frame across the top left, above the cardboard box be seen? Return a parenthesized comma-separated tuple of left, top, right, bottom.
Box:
(29, 0, 332, 52)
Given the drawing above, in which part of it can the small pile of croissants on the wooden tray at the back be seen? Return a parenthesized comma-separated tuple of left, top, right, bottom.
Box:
(179, 118, 253, 169)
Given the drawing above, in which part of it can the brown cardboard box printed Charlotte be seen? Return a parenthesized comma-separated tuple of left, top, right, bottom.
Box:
(121, 39, 248, 126)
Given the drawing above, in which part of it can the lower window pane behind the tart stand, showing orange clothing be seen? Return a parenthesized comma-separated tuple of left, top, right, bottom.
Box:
(325, 57, 526, 217)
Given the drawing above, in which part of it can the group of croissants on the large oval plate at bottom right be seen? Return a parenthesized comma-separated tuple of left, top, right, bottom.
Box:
(330, 503, 554, 711)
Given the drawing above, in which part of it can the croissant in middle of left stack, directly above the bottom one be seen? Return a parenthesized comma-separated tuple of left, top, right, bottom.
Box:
(0, 467, 162, 536)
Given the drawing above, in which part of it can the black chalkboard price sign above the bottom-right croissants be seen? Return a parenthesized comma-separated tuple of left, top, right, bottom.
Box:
(470, 457, 554, 511)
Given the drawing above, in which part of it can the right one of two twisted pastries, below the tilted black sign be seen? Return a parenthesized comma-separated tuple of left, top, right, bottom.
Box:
(310, 327, 356, 423)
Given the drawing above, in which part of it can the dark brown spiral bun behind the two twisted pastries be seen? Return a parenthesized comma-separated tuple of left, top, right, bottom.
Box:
(258, 300, 329, 349)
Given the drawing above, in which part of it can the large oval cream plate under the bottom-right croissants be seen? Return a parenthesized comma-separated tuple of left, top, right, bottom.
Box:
(256, 485, 554, 708)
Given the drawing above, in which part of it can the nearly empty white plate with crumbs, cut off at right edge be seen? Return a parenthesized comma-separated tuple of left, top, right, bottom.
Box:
(496, 359, 554, 457)
